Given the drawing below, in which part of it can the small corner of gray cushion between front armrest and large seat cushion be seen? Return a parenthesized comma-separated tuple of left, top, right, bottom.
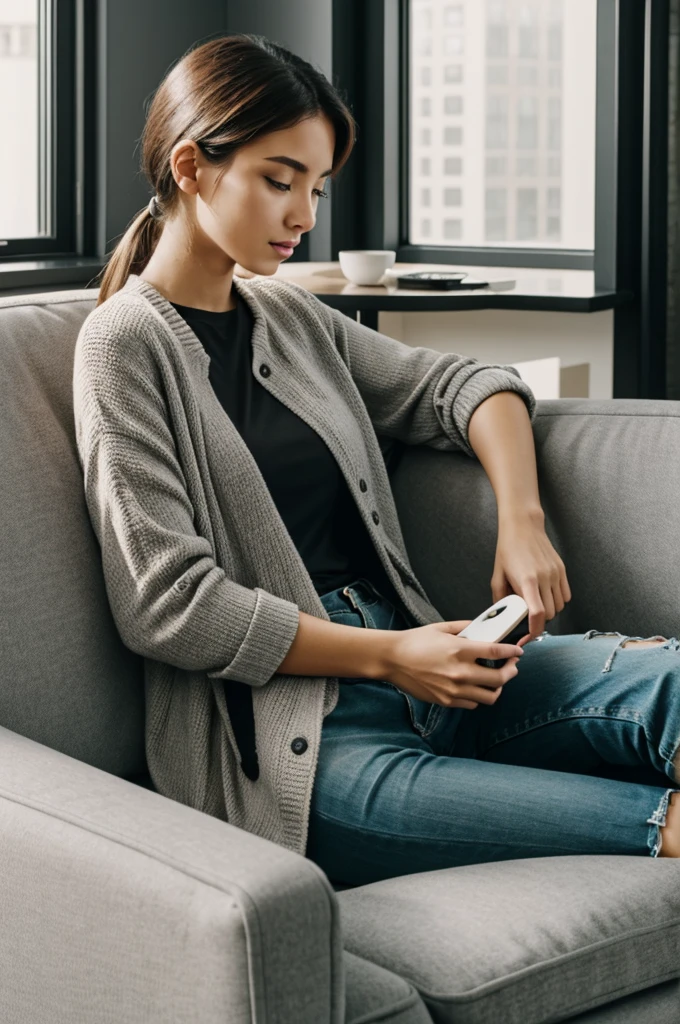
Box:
(344, 950, 432, 1024)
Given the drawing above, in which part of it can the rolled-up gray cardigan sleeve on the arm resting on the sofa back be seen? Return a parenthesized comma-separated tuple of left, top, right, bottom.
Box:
(317, 300, 536, 459)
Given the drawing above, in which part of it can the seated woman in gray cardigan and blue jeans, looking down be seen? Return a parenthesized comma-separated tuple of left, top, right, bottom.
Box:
(74, 28, 680, 885)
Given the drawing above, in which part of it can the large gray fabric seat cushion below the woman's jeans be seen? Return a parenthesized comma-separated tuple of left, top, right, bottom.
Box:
(337, 854, 680, 1024)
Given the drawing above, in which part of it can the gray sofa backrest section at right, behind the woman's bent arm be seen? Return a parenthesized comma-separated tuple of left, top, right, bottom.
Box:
(391, 398, 680, 637)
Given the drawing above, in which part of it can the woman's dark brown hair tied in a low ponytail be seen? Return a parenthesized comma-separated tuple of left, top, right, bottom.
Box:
(97, 35, 356, 305)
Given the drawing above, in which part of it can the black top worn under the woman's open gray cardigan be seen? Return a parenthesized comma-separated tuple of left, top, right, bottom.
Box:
(171, 291, 400, 778)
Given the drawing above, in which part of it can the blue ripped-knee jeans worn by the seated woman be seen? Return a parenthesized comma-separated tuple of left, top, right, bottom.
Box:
(306, 579, 680, 886)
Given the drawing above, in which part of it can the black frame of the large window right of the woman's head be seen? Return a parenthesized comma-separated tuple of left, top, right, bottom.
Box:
(329, 0, 670, 398)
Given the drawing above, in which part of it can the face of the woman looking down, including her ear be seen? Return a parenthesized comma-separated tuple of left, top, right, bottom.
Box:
(170, 115, 335, 274)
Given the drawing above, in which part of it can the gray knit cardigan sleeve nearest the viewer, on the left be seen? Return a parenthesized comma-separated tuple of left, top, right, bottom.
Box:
(74, 310, 299, 686)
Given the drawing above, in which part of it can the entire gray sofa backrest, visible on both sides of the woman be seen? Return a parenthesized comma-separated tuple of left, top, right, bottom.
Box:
(0, 289, 680, 780)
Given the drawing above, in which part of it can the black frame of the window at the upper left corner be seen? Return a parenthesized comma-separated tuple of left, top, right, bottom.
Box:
(0, 0, 95, 269)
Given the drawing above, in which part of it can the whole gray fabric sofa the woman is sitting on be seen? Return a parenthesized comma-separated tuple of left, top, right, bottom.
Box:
(0, 282, 680, 1024)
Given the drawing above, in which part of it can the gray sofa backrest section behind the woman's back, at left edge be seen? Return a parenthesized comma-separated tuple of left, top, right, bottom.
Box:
(0, 289, 146, 778)
